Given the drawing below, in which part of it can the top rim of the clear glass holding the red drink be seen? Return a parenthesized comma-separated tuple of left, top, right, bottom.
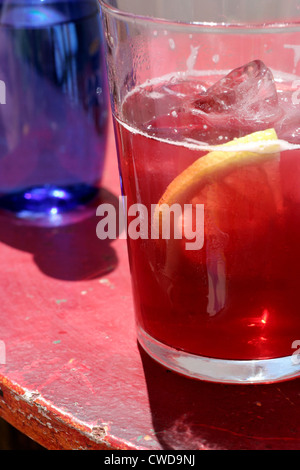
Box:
(98, 0, 300, 33)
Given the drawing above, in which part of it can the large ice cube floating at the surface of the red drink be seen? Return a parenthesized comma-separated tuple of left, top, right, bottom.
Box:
(194, 60, 280, 132)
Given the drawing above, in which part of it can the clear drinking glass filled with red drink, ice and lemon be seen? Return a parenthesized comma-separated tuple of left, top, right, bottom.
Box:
(100, 0, 300, 383)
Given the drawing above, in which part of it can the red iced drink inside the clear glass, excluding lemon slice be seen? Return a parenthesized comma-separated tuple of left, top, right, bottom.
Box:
(115, 61, 300, 360)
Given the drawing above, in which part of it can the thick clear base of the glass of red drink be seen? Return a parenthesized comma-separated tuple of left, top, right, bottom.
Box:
(137, 327, 300, 384)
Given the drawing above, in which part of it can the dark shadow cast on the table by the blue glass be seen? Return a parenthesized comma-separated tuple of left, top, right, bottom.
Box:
(0, 189, 119, 281)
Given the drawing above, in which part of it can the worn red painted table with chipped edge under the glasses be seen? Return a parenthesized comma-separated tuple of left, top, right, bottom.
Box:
(0, 122, 300, 450)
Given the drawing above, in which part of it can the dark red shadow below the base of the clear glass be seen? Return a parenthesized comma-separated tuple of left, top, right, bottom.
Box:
(140, 348, 300, 450)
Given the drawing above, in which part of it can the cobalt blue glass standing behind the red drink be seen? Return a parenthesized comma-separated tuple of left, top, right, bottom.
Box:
(0, 0, 108, 225)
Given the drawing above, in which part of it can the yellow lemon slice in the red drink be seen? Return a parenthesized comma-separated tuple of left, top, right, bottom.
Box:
(154, 129, 280, 232)
